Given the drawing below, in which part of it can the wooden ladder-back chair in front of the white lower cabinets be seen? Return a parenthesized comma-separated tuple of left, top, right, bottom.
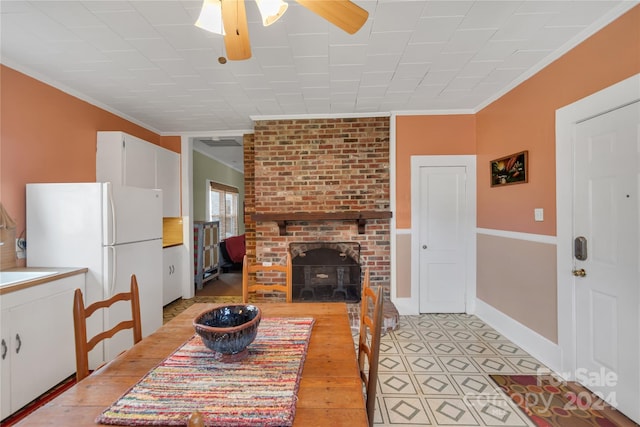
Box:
(73, 274, 142, 381)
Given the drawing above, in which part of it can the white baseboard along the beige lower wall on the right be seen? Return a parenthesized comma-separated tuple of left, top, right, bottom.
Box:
(475, 298, 561, 373)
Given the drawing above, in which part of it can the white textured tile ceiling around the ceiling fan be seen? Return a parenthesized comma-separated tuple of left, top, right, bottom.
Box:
(0, 0, 635, 142)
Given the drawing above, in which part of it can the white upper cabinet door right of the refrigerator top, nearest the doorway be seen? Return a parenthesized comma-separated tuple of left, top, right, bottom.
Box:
(156, 147, 180, 217)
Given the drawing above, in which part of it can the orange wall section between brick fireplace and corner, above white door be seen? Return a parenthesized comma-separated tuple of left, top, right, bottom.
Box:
(395, 115, 476, 228)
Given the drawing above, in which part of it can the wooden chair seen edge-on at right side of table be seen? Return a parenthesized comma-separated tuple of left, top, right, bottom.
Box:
(358, 269, 383, 426)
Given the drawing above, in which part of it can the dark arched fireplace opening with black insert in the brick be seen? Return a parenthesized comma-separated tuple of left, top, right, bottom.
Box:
(289, 242, 360, 302)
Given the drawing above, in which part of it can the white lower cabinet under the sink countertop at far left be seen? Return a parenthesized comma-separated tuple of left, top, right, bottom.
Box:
(0, 274, 85, 419)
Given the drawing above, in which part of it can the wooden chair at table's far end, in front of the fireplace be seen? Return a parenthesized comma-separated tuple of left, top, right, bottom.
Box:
(242, 252, 292, 304)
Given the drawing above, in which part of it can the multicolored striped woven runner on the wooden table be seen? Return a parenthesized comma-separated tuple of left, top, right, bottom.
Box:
(96, 318, 314, 426)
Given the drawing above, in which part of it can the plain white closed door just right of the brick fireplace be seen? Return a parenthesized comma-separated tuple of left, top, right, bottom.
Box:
(418, 166, 467, 313)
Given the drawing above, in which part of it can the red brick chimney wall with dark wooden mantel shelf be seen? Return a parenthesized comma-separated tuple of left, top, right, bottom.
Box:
(244, 117, 391, 295)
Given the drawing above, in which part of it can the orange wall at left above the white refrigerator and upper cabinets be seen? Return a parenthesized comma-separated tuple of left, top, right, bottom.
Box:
(0, 65, 180, 251)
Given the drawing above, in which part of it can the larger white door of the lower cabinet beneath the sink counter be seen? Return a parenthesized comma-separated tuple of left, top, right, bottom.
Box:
(8, 289, 76, 411)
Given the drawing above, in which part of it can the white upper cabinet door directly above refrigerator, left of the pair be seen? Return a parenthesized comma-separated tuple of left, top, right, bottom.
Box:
(123, 135, 156, 188)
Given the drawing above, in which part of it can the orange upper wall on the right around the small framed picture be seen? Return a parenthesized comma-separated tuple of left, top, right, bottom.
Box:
(476, 6, 640, 236)
